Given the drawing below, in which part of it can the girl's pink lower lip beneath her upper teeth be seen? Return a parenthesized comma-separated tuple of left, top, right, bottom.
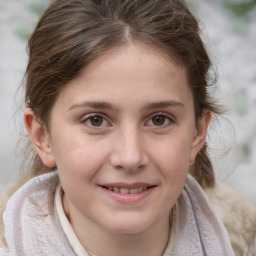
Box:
(101, 187, 156, 203)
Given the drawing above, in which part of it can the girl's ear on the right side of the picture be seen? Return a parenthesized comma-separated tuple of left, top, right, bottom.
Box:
(190, 111, 212, 163)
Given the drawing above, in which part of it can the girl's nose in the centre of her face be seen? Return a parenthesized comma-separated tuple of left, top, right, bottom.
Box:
(110, 128, 149, 172)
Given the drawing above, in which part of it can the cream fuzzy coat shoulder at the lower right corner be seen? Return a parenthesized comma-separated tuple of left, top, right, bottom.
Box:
(204, 182, 256, 255)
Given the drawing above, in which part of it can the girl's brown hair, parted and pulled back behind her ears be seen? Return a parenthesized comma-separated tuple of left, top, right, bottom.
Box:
(25, 0, 219, 187)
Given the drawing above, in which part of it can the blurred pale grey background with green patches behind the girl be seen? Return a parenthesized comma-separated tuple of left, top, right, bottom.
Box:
(0, 0, 256, 205)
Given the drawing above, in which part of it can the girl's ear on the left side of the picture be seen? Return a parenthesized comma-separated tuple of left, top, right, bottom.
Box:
(24, 108, 56, 168)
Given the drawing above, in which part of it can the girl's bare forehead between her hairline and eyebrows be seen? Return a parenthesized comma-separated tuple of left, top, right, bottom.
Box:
(54, 44, 191, 112)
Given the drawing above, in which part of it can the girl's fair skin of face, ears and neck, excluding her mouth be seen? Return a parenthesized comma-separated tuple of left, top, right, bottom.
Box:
(24, 44, 211, 256)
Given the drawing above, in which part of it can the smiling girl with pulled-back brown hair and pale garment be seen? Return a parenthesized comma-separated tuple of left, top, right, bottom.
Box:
(0, 0, 255, 256)
